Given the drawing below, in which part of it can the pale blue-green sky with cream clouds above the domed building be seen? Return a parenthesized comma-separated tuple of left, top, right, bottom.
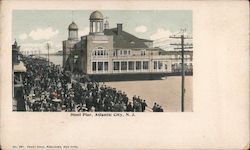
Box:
(12, 10, 192, 52)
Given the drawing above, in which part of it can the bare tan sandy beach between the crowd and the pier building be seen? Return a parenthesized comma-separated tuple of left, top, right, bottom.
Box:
(105, 76, 193, 112)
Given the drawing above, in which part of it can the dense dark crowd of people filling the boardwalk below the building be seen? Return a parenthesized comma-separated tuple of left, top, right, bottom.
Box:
(20, 57, 163, 112)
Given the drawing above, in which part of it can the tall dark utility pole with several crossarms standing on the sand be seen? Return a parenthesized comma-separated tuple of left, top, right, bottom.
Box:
(169, 29, 193, 112)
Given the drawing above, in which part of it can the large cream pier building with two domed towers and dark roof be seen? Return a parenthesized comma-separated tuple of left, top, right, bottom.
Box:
(63, 11, 191, 78)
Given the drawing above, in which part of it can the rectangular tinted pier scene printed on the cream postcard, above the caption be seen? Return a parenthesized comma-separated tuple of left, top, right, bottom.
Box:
(12, 10, 193, 112)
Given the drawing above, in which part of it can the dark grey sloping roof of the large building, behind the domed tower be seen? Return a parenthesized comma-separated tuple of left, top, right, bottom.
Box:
(104, 28, 152, 48)
